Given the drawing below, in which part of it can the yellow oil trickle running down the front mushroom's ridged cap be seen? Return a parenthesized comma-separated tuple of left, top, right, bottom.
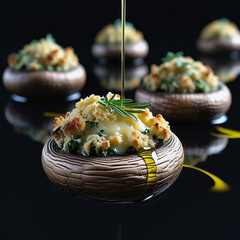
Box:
(138, 149, 157, 187)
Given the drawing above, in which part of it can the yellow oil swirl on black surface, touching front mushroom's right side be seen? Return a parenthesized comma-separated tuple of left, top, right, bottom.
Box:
(183, 164, 231, 193)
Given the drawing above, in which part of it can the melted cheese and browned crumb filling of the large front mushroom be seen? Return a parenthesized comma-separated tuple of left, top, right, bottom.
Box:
(52, 93, 171, 156)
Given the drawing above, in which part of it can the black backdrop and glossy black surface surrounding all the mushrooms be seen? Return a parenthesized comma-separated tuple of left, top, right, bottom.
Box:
(0, 0, 240, 240)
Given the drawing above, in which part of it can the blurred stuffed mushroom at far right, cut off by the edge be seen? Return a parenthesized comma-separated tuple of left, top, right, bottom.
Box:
(197, 18, 240, 54)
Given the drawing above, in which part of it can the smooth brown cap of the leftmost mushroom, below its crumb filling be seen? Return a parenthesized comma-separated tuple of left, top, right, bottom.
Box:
(3, 65, 86, 99)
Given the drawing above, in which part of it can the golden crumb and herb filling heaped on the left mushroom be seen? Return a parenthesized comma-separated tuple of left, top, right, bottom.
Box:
(8, 34, 79, 72)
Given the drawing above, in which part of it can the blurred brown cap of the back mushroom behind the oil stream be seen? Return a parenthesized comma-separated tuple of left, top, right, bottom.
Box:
(92, 40, 149, 59)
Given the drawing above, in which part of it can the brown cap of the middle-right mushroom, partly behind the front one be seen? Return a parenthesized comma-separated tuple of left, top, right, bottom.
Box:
(135, 83, 232, 122)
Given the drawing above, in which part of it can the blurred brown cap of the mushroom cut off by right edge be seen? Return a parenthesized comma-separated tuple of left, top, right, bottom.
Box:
(196, 36, 240, 54)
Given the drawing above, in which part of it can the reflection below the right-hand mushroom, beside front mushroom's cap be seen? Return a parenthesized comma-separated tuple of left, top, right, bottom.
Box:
(172, 123, 228, 165)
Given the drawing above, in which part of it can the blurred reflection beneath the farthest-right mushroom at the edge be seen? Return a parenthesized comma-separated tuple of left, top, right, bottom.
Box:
(200, 56, 240, 83)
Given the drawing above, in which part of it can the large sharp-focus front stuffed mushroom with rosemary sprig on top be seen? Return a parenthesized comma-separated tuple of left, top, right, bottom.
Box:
(42, 93, 184, 201)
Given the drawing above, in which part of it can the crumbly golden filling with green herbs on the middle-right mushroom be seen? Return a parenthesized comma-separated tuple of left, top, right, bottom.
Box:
(143, 52, 220, 93)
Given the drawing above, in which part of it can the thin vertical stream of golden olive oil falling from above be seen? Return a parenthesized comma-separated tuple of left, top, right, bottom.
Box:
(121, 0, 126, 107)
